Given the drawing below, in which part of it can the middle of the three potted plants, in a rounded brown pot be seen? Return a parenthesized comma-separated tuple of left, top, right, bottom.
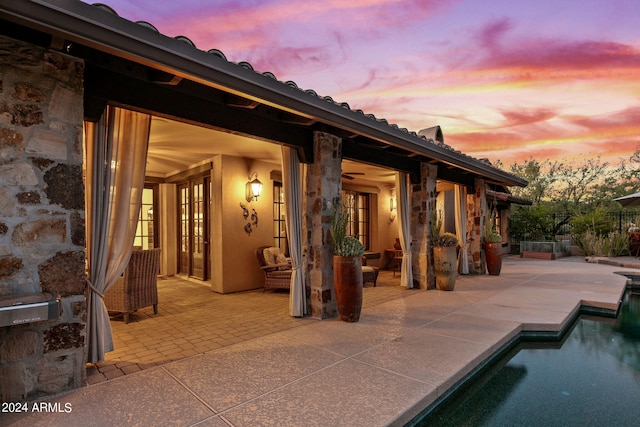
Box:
(431, 215, 458, 291)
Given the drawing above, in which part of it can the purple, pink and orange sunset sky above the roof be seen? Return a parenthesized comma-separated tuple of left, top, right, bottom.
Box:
(103, 0, 640, 165)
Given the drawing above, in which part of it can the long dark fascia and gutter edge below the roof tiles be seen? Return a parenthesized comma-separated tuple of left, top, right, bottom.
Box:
(0, 0, 527, 186)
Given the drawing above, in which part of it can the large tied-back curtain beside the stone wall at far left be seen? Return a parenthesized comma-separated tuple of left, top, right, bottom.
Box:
(84, 106, 151, 363)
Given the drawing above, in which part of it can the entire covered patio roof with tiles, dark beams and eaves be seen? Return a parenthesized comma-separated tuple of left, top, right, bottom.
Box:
(0, 0, 527, 186)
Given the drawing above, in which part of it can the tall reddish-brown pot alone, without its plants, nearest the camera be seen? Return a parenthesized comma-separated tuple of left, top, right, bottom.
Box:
(333, 256, 362, 322)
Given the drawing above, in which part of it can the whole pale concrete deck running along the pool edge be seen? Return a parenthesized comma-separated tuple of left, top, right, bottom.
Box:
(0, 258, 627, 426)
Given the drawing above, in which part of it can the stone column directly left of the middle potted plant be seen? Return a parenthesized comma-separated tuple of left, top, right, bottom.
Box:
(411, 163, 438, 289)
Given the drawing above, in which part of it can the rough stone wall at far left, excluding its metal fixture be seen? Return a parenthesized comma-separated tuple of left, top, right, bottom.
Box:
(0, 36, 86, 402)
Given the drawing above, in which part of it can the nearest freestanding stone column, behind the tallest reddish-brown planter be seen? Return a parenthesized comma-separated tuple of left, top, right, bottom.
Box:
(302, 132, 342, 319)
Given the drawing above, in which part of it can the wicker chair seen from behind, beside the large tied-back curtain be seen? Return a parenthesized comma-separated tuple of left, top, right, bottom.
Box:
(104, 249, 160, 323)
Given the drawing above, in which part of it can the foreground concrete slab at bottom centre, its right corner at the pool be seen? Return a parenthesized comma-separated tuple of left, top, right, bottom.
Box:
(224, 359, 435, 427)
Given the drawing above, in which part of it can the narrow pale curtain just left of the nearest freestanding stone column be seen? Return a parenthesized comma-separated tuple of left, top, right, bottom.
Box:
(282, 145, 307, 317)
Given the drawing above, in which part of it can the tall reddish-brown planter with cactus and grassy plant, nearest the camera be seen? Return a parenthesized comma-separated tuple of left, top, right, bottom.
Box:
(331, 203, 365, 322)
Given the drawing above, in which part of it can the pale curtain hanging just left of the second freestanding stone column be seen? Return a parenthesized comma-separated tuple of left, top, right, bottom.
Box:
(396, 172, 413, 289)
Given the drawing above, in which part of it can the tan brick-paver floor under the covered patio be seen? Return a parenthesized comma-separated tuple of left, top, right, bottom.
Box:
(87, 270, 408, 384)
